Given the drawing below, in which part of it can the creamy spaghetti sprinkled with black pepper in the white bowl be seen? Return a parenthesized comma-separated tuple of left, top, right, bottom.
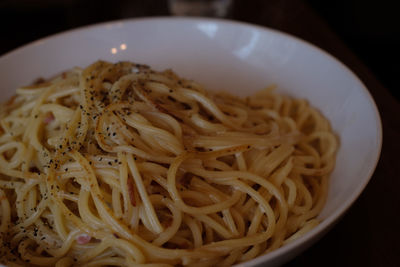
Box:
(0, 61, 337, 266)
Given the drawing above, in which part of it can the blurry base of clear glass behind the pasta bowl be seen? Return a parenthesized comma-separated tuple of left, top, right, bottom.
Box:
(168, 0, 232, 18)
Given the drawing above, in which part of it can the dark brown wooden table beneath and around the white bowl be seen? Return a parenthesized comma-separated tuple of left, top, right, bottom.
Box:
(0, 0, 400, 267)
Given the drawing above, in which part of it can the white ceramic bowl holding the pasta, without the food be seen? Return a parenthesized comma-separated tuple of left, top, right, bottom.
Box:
(0, 18, 382, 266)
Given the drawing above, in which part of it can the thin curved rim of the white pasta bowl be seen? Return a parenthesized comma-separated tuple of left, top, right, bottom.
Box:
(0, 16, 383, 266)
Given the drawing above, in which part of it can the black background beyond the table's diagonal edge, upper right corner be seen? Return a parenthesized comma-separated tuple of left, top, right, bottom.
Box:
(308, 0, 400, 99)
